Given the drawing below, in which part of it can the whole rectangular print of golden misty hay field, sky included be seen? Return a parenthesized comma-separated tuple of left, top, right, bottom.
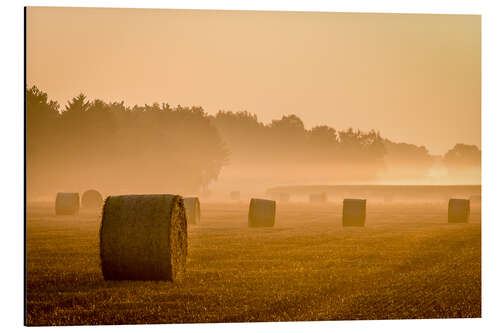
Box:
(24, 8, 482, 326)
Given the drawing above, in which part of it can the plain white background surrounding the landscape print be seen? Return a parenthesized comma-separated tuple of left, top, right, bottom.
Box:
(0, 0, 500, 333)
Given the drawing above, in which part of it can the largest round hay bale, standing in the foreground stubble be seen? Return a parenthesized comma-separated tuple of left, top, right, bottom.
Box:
(100, 194, 187, 281)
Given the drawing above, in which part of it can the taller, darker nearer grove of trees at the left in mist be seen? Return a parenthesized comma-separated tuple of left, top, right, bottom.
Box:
(26, 87, 228, 195)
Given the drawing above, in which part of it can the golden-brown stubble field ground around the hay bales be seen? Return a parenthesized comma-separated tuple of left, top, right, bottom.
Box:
(26, 201, 481, 325)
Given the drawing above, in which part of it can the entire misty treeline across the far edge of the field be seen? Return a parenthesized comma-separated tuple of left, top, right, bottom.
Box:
(26, 86, 480, 200)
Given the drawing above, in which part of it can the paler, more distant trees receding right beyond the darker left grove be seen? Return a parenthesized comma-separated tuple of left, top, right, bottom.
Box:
(212, 111, 481, 183)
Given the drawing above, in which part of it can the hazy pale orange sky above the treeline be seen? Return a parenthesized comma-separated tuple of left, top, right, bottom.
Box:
(26, 7, 481, 154)
